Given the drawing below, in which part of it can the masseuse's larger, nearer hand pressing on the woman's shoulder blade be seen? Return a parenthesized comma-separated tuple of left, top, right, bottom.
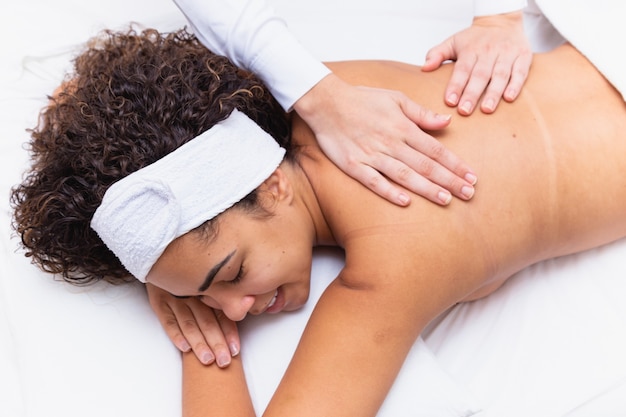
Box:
(294, 74, 476, 206)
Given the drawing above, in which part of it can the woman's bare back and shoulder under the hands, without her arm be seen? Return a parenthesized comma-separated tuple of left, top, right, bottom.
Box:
(294, 46, 626, 302)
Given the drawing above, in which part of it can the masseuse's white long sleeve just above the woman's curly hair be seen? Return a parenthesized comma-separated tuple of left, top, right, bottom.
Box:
(174, 0, 330, 110)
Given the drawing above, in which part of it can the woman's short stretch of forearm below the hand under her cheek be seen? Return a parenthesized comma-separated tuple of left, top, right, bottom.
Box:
(183, 353, 255, 417)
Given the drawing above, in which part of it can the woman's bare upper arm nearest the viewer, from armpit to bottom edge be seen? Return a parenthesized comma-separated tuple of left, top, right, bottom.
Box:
(265, 258, 460, 417)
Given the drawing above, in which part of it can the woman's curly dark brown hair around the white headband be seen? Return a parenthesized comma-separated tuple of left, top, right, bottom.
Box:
(11, 28, 290, 284)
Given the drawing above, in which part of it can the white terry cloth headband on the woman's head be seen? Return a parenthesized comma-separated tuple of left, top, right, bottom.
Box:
(91, 110, 285, 282)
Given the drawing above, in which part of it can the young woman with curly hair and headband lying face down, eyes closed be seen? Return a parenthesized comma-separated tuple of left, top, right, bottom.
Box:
(12, 27, 626, 416)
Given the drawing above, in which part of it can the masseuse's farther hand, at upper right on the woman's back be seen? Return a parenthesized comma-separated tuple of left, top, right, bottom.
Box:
(422, 11, 532, 115)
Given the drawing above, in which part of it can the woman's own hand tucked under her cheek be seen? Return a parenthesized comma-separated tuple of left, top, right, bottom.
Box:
(146, 284, 240, 368)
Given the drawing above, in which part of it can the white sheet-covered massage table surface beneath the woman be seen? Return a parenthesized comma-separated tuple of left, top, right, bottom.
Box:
(0, 0, 626, 417)
